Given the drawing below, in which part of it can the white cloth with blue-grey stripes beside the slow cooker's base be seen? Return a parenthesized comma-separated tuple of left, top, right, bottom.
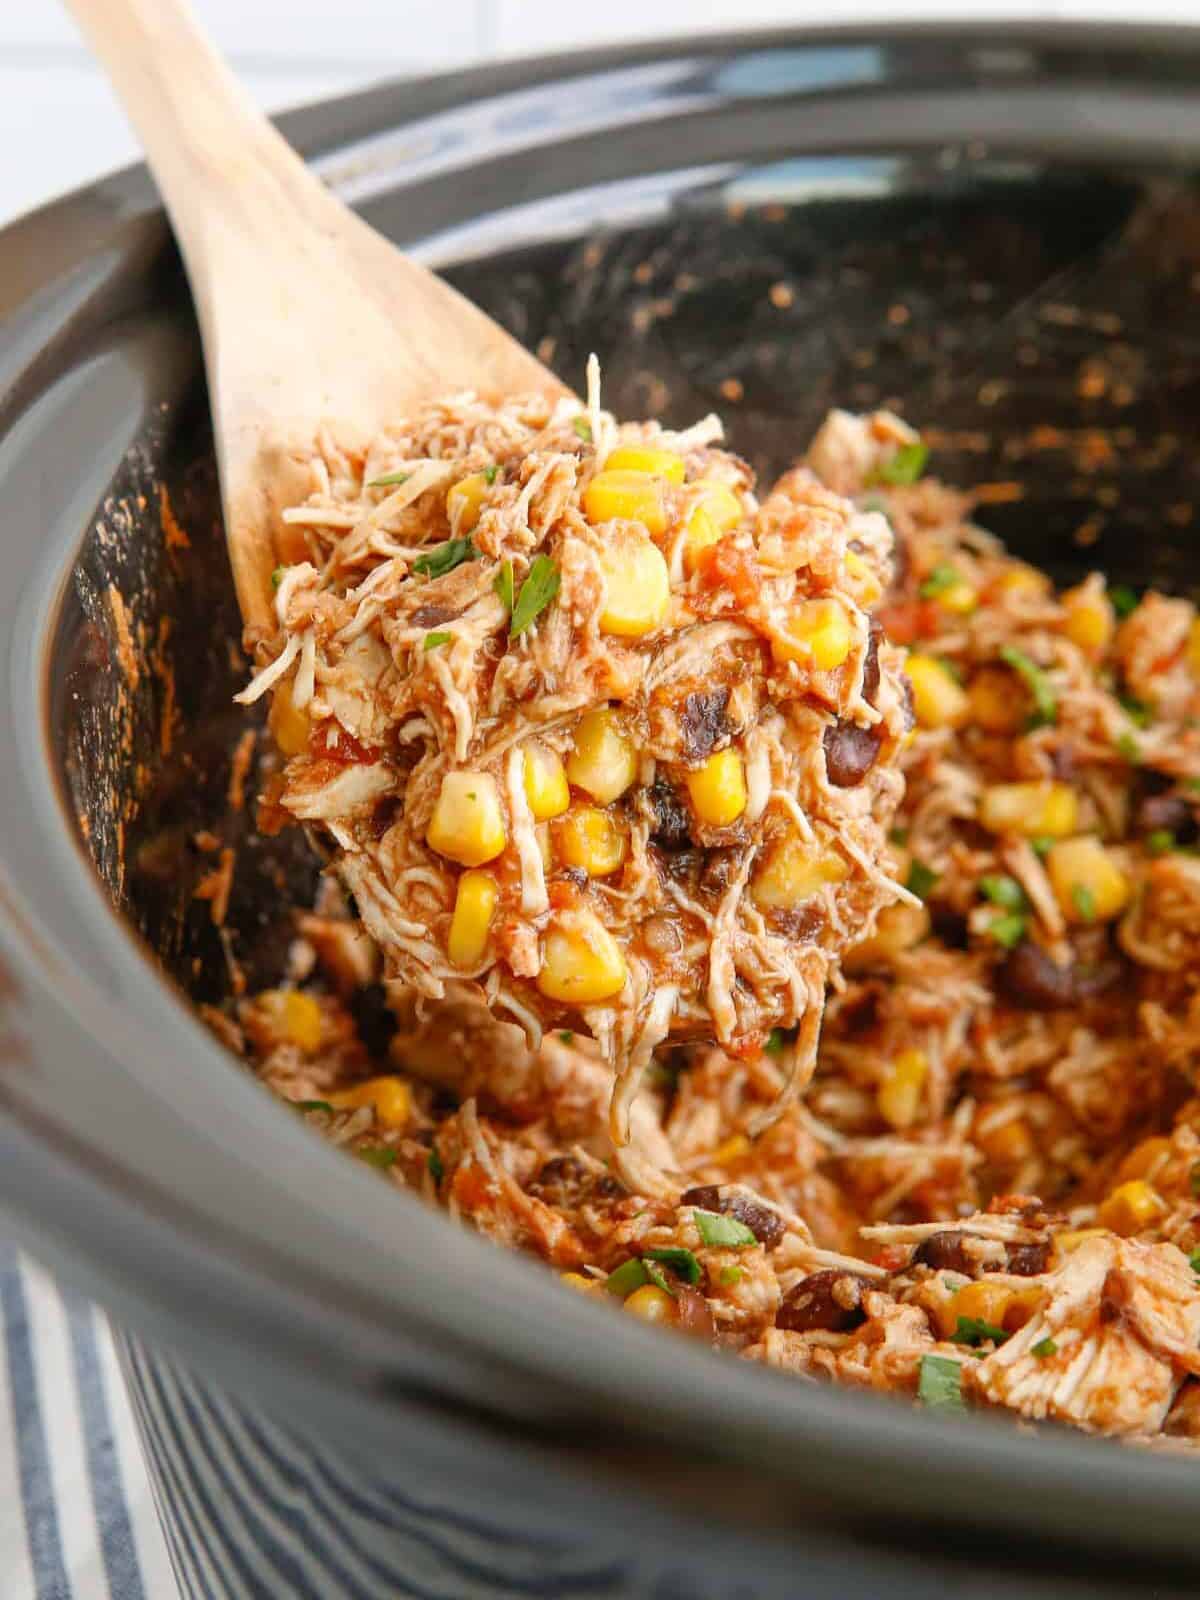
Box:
(0, 1245, 178, 1600)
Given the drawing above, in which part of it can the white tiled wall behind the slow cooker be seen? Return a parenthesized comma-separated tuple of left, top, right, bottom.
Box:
(0, 0, 1200, 222)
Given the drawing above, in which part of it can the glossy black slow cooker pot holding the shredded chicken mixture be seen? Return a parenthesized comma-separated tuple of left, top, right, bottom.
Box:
(0, 27, 1200, 1600)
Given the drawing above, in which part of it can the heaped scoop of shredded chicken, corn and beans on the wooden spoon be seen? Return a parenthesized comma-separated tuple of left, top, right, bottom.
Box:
(240, 371, 910, 1160)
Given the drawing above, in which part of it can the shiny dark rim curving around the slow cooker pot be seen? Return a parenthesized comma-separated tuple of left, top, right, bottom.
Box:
(0, 21, 1200, 1554)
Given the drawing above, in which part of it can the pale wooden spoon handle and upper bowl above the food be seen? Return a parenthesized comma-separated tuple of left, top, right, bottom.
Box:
(67, 0, 566, 627)
